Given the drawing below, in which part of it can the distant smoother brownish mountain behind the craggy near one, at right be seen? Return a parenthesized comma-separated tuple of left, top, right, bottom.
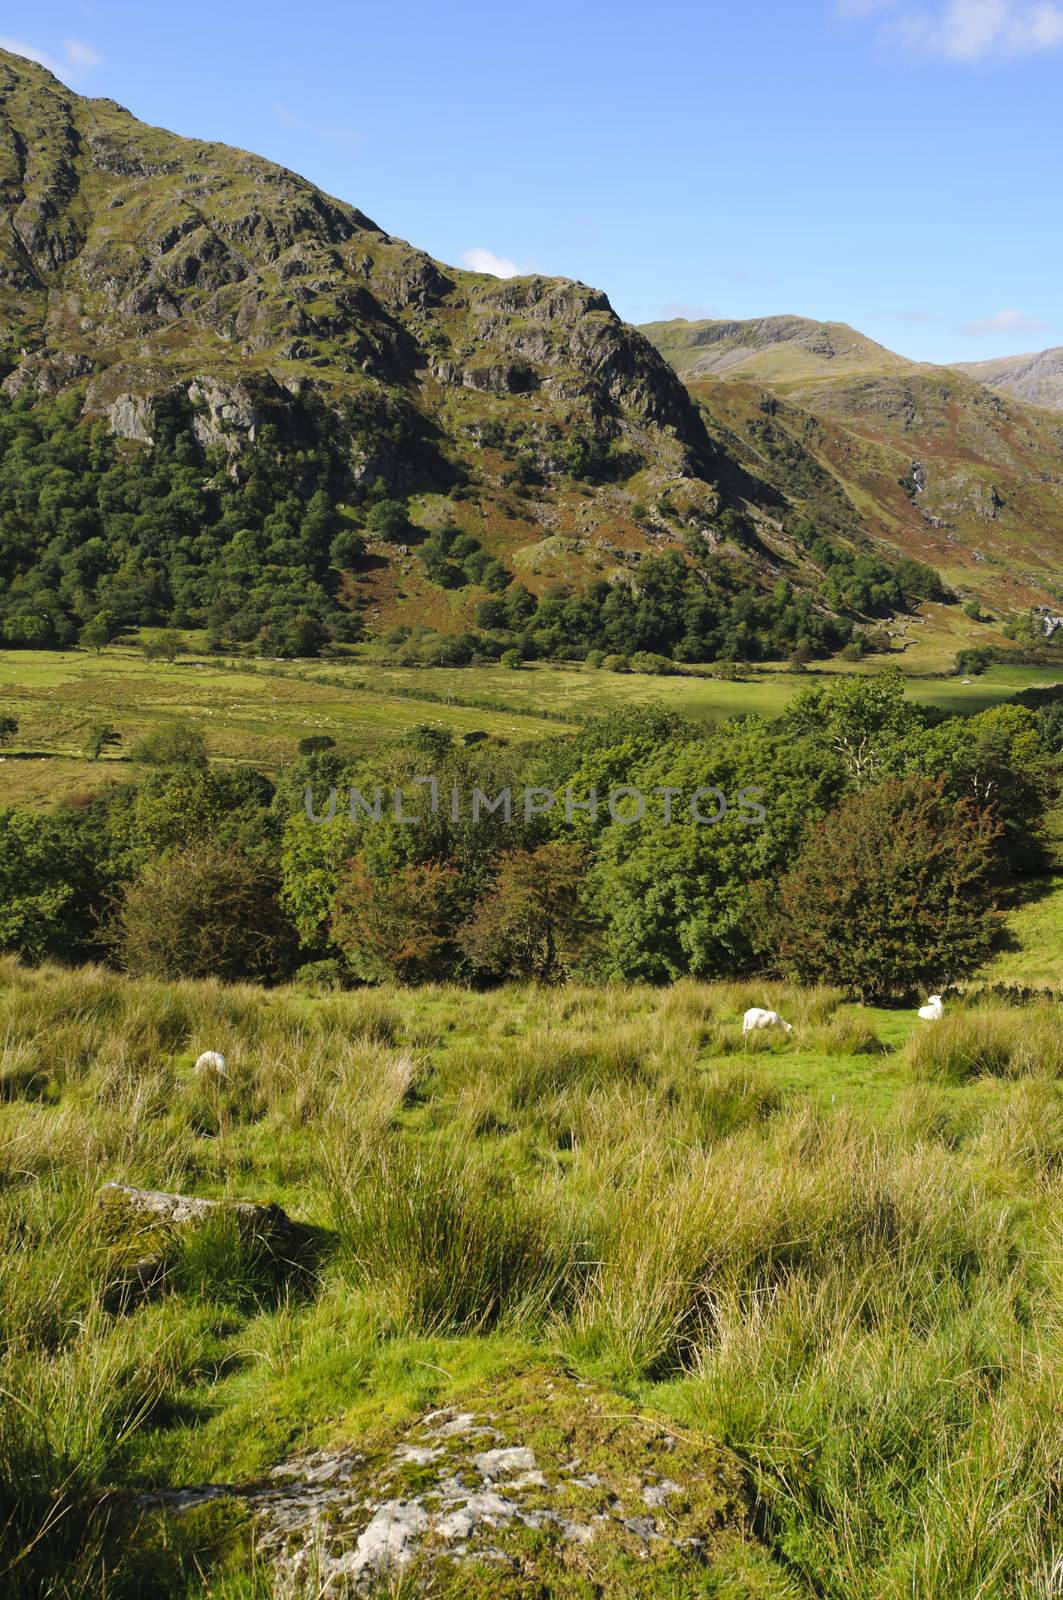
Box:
(644, 317, 1063, 613)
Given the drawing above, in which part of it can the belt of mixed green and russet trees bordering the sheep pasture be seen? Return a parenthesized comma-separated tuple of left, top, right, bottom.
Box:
(0, 674, 1063, 995)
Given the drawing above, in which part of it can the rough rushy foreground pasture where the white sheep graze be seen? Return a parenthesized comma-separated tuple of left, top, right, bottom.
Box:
(0, 962, 1063, 1600)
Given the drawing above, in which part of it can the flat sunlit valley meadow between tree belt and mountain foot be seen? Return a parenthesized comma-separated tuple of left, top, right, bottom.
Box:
(0, 646, 1053, 806)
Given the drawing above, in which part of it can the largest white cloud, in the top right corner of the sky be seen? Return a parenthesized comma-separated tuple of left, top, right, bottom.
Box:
(837, 0, 1063, 62)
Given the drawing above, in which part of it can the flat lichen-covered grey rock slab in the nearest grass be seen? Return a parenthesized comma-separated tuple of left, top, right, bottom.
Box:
(141, 1371, 773, 1600)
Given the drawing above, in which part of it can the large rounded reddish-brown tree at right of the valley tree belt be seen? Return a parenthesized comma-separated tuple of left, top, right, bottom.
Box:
(764, 778, 999, 1000)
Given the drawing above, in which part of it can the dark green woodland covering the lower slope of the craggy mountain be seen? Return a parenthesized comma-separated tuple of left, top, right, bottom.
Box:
(0, 392, 940, 666)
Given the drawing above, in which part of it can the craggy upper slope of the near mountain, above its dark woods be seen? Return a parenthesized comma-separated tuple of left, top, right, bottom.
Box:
(0, 51, 711, 488)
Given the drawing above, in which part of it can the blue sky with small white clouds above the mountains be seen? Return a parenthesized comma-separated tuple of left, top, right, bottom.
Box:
(0, 0, 1063, 362)
